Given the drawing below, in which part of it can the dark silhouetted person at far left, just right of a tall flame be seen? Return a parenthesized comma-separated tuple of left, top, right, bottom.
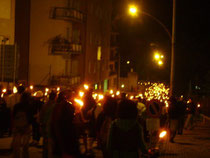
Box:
(12, 93, 32, 158)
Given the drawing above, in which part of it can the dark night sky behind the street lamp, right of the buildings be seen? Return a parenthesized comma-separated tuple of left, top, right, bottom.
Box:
(116, 0, 210, 94)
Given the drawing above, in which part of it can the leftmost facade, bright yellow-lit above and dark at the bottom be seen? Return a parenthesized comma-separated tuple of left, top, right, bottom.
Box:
(0, 0, 17, 83)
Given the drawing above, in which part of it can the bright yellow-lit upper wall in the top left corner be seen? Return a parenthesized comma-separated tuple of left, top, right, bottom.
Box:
(0, 0, 15, 44)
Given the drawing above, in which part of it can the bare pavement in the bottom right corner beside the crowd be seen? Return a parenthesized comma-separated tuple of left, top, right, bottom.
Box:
(161, 123, 210, 158)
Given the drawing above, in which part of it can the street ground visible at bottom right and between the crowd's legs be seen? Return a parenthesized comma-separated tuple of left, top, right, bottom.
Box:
(0, 122, 210, 158)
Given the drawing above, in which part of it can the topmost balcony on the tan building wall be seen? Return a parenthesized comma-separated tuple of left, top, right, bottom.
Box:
(51, 7, 86, 23)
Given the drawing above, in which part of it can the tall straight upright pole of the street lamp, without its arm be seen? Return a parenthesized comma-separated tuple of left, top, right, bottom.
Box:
(170, 0, 176, 96)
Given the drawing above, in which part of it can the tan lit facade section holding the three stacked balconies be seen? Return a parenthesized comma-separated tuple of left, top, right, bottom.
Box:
(29, 0, 86, 86)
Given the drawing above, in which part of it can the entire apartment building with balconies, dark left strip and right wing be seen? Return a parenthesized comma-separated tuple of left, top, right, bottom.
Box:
(15, 0, 112, 89)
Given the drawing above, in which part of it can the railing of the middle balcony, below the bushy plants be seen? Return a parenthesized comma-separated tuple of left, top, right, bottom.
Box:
(50, 43, 82, 55)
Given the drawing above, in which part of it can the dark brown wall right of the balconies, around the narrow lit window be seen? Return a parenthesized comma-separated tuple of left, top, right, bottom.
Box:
(85, 0, 112, 87)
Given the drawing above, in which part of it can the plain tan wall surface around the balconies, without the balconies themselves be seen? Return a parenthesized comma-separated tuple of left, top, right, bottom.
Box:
(29, 0, 82, 85)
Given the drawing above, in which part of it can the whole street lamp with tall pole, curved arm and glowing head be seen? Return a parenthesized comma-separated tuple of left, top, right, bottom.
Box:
(129, 0, 176, 96)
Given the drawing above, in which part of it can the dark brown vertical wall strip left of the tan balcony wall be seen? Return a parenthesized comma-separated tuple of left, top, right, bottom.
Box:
(15, 0, 30, 82)
